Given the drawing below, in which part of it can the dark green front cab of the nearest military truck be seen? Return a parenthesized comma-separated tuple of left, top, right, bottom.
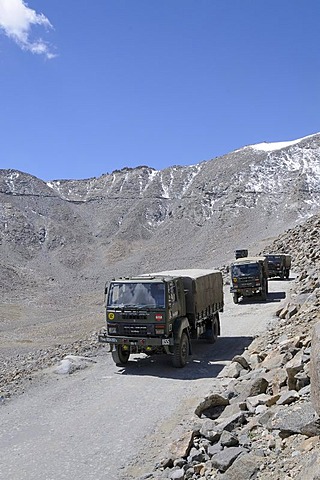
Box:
(99, 276, 186, 364)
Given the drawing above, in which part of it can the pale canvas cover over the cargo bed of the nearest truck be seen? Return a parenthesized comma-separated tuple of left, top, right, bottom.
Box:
(144, 269, 223, 315)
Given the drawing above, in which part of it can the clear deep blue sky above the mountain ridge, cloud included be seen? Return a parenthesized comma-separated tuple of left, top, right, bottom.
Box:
(0, 0, 320, 180)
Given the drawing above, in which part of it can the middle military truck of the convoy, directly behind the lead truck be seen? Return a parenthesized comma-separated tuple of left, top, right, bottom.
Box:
(230, 257, 268, 303)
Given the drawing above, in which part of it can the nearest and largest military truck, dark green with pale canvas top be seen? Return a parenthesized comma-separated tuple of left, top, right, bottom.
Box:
(99, 269, 224, 368)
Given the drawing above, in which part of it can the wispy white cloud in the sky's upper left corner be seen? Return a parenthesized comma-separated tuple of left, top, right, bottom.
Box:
(0, 0, 55, 58)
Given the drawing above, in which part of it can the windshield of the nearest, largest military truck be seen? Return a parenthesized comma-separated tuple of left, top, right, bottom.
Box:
(107, 282, 165, 308)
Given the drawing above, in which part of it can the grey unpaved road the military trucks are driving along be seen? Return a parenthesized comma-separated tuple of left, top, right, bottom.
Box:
(0, 280, 291, 480)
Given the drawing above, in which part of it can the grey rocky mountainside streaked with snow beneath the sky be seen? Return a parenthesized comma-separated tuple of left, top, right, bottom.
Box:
(0, 134, 320, 296)
